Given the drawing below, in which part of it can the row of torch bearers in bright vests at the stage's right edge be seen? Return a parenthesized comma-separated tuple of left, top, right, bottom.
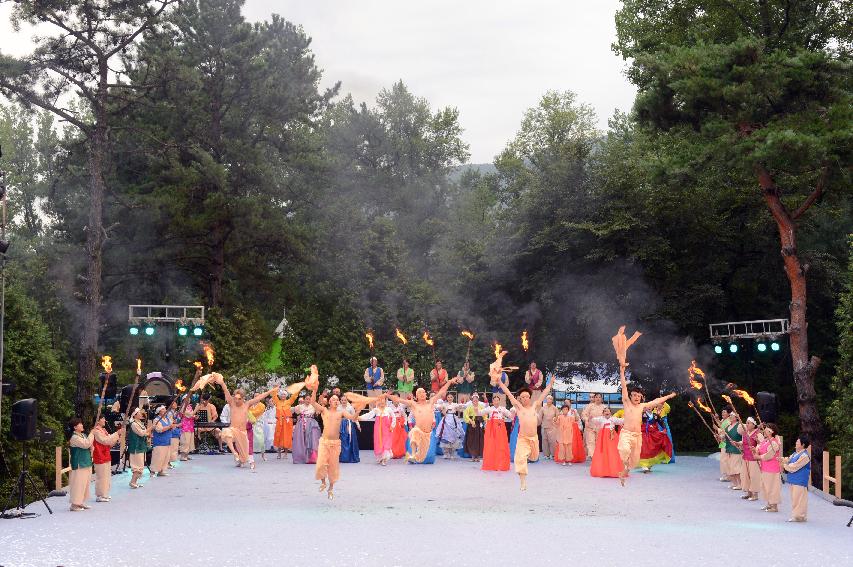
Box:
(715, 406, 811, 522)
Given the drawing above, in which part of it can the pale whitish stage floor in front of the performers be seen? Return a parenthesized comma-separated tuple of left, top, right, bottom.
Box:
(0, 451, 853, 567)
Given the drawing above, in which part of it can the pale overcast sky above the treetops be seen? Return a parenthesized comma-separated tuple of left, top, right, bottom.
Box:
(0, 0, 636, 163)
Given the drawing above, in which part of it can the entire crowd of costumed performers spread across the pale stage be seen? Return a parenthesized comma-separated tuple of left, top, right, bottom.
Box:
(63, 352, 809, 521)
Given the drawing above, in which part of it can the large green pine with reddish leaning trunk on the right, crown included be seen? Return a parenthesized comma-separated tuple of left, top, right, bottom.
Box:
(614, 0, 853, 477)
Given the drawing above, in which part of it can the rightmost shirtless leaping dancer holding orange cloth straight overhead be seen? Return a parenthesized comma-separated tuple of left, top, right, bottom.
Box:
(613, 327, 675, 486)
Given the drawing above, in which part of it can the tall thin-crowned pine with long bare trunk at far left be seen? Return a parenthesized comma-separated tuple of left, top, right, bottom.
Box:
(0, 0, 177, 415)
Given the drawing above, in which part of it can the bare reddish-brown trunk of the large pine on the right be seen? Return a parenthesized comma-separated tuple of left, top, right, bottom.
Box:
(758, 168, 826, 484)
